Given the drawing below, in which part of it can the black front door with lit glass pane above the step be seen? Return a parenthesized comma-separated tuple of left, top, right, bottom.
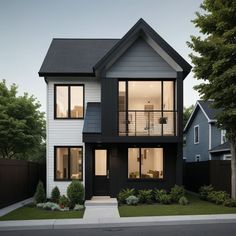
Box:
(93, 149, 109, 196)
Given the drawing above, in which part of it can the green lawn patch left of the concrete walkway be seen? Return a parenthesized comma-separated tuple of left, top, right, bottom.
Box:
(0, 206, 84, 221)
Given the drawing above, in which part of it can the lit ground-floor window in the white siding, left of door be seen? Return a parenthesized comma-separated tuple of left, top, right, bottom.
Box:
(55, 147, 83, 180)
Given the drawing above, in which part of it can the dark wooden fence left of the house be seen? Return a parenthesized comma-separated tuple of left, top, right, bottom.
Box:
(0, 159, 46, 208)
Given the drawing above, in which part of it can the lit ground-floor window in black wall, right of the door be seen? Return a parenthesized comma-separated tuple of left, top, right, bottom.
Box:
(128, 148, 163, 179)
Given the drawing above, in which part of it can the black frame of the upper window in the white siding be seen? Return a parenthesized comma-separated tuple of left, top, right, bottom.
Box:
(54, 84, 85, 120)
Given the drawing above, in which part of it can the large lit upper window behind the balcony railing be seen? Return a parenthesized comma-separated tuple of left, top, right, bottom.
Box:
(119, 81, 176, 136)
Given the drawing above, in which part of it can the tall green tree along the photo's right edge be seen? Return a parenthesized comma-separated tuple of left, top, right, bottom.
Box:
(188, 0, 236, 197)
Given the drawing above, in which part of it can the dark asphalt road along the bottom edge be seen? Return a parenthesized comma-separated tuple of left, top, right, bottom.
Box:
(0, 223, 236, 236)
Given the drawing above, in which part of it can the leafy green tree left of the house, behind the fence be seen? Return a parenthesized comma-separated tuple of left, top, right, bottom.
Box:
(0, 80, 45, 159)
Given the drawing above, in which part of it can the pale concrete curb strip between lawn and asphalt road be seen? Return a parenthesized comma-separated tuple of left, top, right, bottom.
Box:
(0, 214, 236, 231)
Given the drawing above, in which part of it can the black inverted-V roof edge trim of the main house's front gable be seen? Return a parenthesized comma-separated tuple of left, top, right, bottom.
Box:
(94, 18, 192, 78)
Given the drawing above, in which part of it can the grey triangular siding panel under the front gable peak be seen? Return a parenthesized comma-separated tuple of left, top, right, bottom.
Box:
(106, 38, 177, 78)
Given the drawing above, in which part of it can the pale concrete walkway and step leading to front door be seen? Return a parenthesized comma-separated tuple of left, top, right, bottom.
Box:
(83, 196, 120, 219)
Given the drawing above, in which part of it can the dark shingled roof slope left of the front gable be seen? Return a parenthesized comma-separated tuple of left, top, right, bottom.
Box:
(39, 39, 119, 76)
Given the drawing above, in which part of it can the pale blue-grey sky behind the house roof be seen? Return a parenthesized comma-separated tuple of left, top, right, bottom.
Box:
(0, 0, 202, 111)
